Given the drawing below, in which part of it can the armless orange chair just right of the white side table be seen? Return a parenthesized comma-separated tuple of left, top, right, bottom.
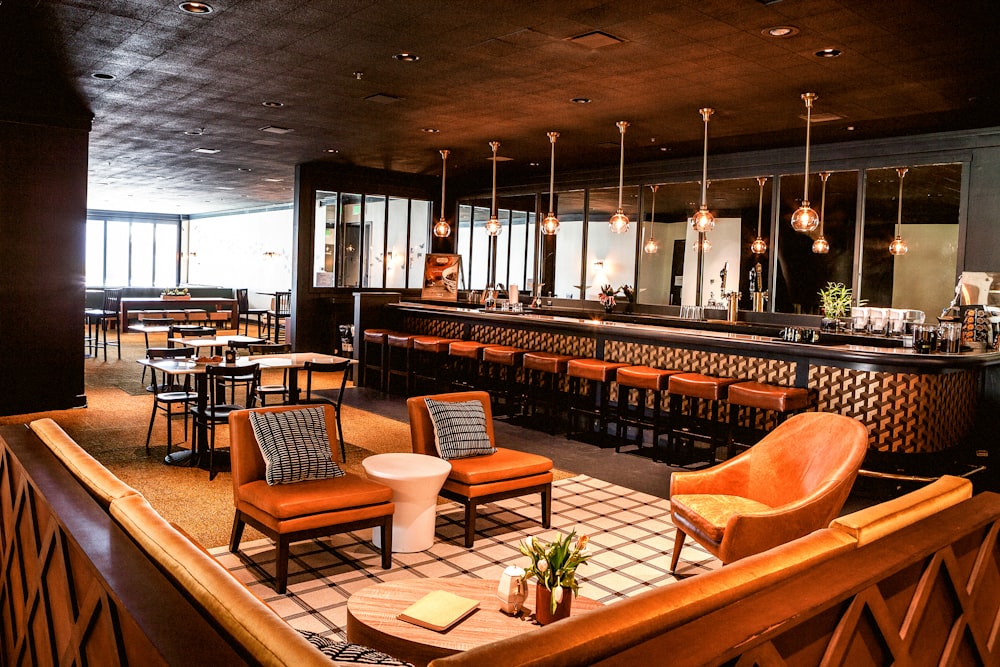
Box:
(406, 391, 552, 548)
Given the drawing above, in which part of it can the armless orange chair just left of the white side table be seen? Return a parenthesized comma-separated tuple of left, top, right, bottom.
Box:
(229, 405, 394, 593)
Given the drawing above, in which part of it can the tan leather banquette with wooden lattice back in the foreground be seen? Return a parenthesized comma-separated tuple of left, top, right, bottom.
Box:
(0, 420, 1000, 667)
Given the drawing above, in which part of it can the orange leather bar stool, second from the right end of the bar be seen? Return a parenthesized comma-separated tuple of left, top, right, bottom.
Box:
(667, 373, 739, 463)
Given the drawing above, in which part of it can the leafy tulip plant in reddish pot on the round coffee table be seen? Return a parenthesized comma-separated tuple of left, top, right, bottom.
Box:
(518, 530, 591, 625)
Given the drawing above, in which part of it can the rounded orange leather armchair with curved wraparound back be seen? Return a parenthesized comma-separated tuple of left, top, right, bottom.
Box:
(670, 412, 868, 571)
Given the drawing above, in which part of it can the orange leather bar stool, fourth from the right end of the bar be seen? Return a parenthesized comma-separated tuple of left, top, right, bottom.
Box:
(566, 359, 629, 445)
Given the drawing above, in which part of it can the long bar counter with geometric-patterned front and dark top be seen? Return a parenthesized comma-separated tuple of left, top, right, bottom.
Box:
(389, 302, 1000, 454)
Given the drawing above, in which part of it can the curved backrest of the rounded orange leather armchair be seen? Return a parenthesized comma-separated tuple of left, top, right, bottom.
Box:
(739, 412, 868, 508)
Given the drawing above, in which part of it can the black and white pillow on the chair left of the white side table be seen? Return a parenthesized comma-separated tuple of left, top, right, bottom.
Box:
(250, 408, 344, 486)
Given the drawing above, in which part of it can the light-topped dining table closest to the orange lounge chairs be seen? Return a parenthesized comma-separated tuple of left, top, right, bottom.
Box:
(138, 352, 357, 466)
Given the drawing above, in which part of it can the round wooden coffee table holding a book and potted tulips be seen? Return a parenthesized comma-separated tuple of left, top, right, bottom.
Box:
(347, 577, 601, 667)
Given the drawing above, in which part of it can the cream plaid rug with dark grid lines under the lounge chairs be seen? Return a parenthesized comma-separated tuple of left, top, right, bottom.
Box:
(212, 475, 720, 639)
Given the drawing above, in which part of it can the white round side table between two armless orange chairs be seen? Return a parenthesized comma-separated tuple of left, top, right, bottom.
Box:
(361, 452, 451, 553)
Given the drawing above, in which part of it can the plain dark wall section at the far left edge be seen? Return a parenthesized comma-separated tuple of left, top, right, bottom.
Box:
(0, 121, 87, 415)
